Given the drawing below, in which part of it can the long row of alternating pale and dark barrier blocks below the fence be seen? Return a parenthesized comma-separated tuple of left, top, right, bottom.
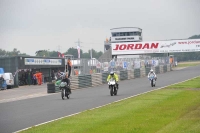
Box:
(48, 65, 171, 93)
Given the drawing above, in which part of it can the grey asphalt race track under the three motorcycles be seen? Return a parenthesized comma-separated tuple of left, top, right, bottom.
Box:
(0, 66, 200, 133)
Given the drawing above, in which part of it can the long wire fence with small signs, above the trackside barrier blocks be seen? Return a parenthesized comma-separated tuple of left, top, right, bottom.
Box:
(71, 57, 169, 77)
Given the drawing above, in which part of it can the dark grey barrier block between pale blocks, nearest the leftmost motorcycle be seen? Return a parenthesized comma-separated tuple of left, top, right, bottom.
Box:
(78, 75, 92, 88)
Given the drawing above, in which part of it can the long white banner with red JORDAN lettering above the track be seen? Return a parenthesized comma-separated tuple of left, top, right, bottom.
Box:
(112, 39, 200, 55)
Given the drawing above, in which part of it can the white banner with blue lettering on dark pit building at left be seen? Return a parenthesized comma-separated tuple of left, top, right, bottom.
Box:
(24, 58, 62, 65)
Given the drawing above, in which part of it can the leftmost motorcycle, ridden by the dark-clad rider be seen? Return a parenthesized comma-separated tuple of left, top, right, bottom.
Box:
(59, 82, 71, 100)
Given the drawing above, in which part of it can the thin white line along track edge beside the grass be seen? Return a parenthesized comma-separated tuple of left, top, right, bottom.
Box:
(14, 76, 199, 133)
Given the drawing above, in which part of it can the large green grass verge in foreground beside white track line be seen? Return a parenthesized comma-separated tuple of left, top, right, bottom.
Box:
(19, 77, 200, 133)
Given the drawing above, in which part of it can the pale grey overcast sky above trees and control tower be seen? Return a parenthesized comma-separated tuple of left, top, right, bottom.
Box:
(0, 0, 200, 55)
